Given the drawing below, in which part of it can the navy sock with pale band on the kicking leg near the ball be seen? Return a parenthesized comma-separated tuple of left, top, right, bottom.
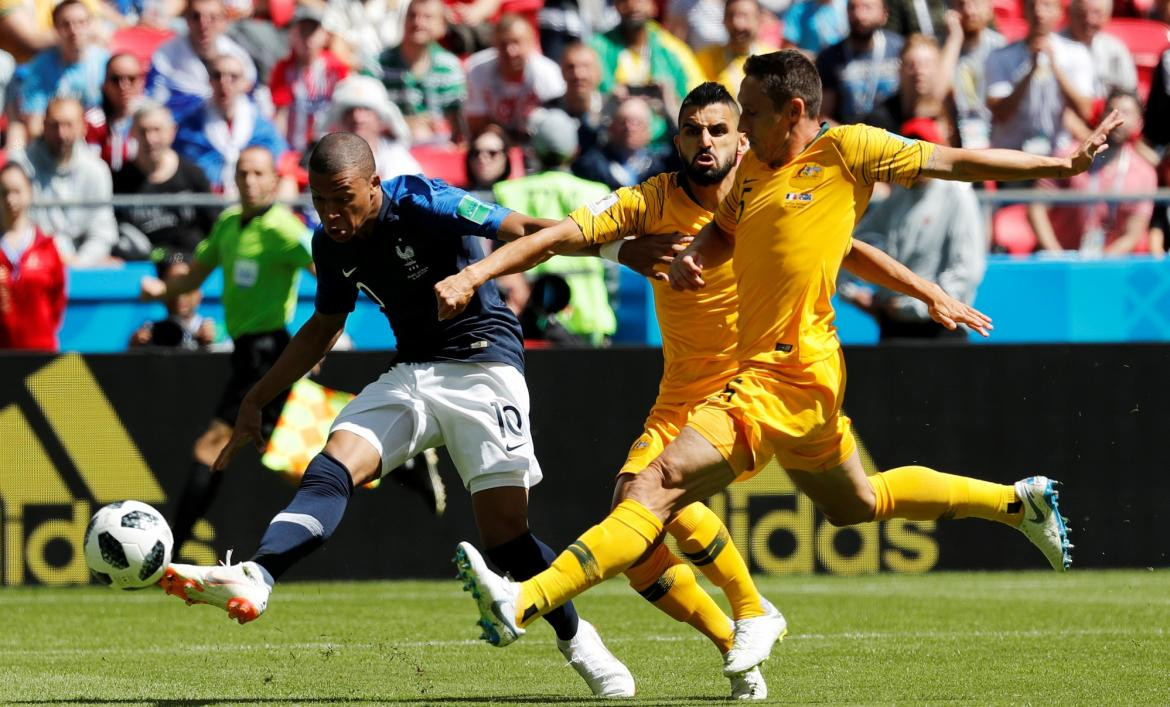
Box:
(252, 452, 353, 579)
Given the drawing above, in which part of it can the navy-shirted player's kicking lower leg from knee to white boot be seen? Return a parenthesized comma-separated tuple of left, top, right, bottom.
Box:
(159, 431, 381, 624)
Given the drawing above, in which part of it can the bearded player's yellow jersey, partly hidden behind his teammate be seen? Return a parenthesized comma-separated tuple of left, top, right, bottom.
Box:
(569, 173, 737, 405)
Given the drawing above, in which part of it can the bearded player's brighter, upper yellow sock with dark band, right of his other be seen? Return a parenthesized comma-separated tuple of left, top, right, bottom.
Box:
(667, 503, 766, 620)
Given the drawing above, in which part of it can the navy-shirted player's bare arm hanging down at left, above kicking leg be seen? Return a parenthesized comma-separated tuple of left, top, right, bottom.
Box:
(212, 311, 349, 471)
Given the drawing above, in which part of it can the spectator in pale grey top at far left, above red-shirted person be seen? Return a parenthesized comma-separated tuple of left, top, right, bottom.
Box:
(8, 98, 118, 267)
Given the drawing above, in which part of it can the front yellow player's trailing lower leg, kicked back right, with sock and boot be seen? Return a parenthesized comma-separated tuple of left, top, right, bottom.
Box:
(789, 452, 1073, 571)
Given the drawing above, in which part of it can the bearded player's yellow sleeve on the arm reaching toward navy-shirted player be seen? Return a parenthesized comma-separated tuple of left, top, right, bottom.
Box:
(569, 173, 674, 245)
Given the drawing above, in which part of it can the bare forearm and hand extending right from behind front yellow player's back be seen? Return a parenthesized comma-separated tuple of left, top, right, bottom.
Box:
(841, 240, 993, 336)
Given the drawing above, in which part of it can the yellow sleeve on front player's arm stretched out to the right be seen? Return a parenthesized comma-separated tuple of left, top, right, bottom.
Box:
(828, 125, 935, 187)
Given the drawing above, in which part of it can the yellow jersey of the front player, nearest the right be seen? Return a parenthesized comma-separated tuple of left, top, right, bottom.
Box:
(715, 125, 934, 365)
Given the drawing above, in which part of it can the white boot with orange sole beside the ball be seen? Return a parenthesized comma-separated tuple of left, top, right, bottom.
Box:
(158, 550, 273, 624)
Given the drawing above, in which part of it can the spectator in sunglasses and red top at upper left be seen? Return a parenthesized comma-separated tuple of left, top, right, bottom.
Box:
(85, 54, 146, 172)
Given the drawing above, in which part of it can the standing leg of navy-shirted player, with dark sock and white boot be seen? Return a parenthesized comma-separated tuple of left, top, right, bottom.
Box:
(472, 486, 634, 698)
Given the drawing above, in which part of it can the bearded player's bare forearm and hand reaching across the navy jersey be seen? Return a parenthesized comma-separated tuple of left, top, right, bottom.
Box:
(434, 213, 586, 321)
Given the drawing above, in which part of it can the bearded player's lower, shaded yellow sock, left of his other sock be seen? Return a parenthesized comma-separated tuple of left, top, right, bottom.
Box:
(626, 543, 734, 653)
